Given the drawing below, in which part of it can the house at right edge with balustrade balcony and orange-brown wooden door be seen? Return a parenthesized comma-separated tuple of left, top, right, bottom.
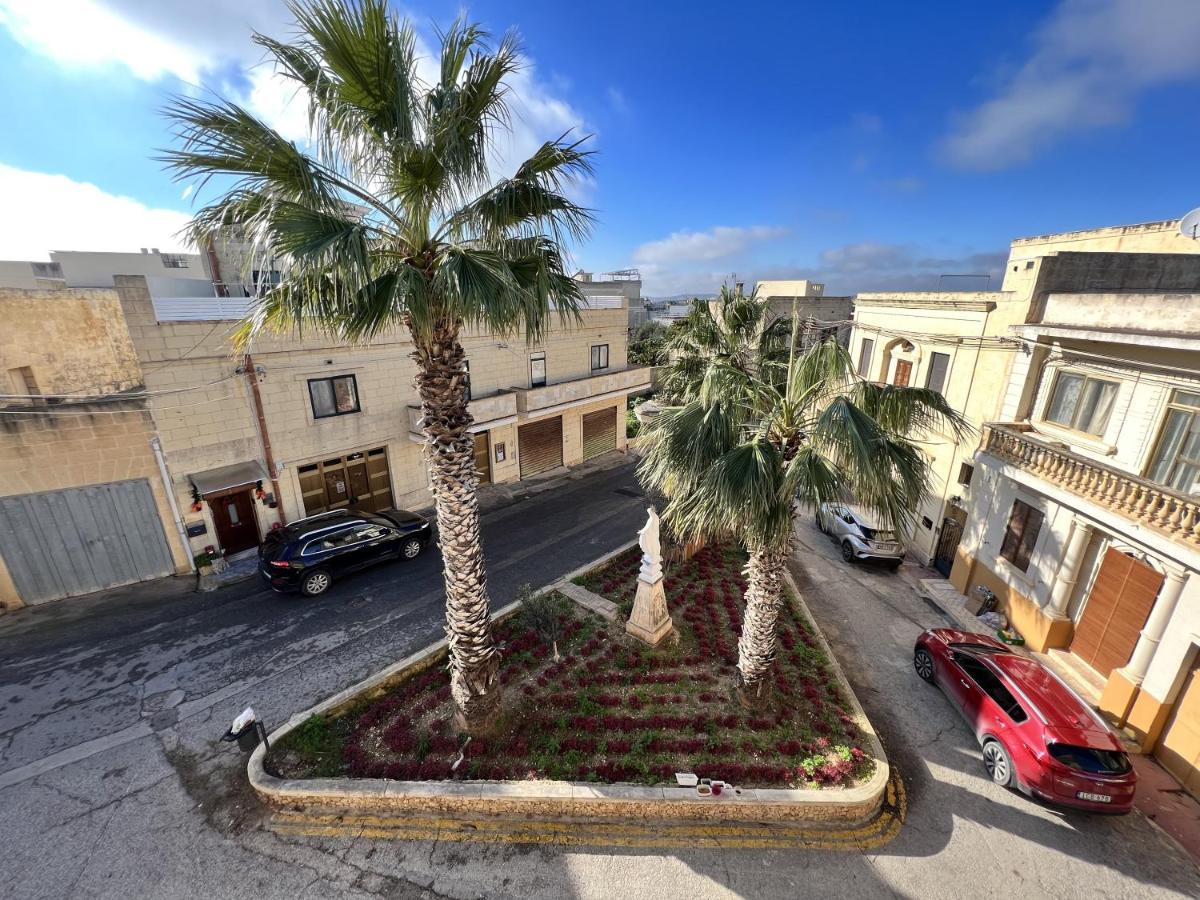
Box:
(950, 285, 1200, 796)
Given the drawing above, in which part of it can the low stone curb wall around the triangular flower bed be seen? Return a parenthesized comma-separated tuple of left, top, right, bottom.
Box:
(246, 541, 892, 828)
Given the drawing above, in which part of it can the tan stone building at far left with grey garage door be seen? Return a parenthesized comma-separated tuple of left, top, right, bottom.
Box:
(0, 289, 191, 606)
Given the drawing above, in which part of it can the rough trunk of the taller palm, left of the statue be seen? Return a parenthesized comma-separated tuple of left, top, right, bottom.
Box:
(413, 322, 500, 734)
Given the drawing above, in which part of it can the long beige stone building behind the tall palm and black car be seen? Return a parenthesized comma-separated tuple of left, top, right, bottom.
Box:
(116, 276, 650, 571)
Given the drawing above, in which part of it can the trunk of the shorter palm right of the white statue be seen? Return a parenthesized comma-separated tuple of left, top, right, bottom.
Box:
(737, 547, 787, 707)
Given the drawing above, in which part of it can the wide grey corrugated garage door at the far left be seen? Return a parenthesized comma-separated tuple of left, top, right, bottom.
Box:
(0, 479, 175, 604)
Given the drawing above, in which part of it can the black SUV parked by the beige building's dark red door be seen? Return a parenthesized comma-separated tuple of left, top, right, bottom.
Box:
(258, 509, 432, 596)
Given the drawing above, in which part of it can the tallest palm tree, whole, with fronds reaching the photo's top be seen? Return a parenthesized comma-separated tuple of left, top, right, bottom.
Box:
(163, 0, 590, 731)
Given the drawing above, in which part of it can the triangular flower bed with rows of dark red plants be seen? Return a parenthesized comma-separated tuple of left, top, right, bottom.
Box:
(266, 547, 874, 787)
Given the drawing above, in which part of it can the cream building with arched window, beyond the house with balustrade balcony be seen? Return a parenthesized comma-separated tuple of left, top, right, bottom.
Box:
(850, 221, 1200, 566)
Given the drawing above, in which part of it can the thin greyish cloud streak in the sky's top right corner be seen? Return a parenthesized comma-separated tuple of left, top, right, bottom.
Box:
(941, 0, 1200, 169)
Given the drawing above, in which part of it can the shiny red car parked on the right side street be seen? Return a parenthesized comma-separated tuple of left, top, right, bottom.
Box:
(913, 628, 1138, 812)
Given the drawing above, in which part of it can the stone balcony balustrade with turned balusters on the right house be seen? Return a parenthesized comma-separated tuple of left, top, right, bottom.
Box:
(983, 424, 1200, 547)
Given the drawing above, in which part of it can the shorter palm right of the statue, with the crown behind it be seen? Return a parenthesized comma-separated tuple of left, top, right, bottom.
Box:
(640, 294, 968, 704)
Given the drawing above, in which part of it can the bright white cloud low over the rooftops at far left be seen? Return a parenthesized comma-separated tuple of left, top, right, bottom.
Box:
(0, 163, 188, 259)
